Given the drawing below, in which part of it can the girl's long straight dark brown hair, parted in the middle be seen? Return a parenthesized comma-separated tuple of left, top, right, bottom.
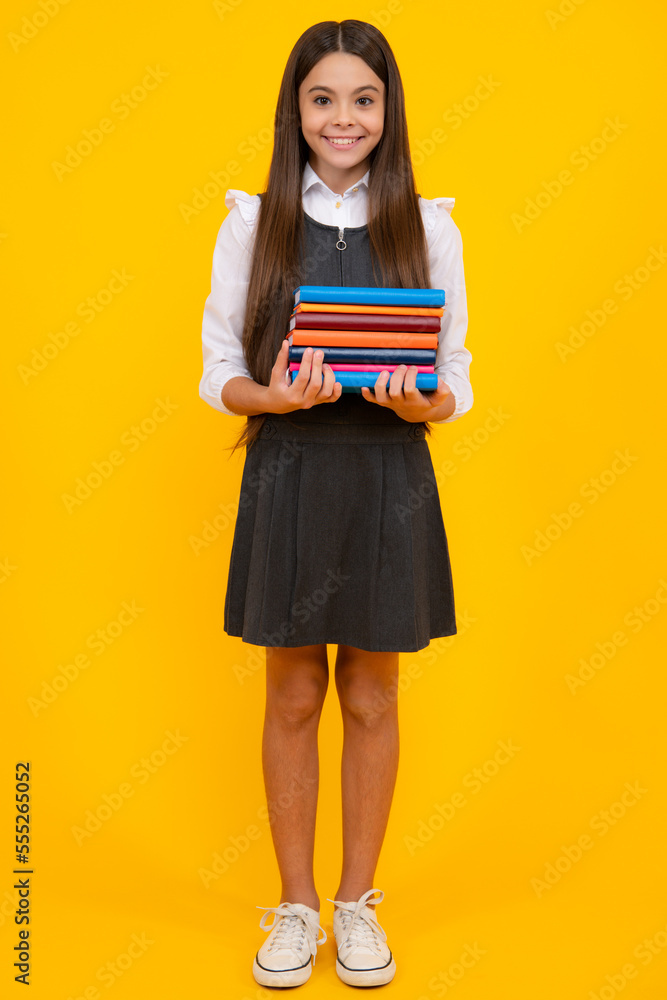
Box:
(226, 20, 431, 453)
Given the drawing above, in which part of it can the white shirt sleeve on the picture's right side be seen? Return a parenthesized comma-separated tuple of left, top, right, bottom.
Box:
(429, 198, 473, 424)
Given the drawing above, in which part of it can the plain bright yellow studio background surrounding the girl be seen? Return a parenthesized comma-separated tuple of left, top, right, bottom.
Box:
(0, 0, 667, 1000)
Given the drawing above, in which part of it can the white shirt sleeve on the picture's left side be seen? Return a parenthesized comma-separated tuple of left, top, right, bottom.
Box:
(199, 203, 252, 416)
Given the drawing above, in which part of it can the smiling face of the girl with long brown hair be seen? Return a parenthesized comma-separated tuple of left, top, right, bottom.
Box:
(299, 52, 385, 194)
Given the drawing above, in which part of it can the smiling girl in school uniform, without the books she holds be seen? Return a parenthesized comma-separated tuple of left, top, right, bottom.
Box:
(200, 20, 472, 986)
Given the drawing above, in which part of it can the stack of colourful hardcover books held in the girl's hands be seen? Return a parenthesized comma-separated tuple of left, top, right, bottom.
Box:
(287, 285, 445, 392)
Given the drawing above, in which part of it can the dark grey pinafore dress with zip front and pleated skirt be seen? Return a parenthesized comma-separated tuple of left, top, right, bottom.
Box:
(224, 204, 456, 653)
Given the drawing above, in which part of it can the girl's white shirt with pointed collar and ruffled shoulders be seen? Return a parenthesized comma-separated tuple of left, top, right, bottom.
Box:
(199, 163, 473, 424)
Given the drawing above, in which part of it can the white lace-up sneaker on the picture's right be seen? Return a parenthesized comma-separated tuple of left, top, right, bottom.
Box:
(327, 889, 396, 986)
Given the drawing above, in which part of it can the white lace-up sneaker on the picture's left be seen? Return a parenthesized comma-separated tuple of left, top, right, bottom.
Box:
(252, 903, 327, 986)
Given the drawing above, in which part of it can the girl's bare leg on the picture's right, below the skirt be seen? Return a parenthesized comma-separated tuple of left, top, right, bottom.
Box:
(335, 645, 399, 903)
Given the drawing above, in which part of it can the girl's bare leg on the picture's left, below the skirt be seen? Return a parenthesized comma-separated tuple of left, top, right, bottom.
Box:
(262, 644, 329, 910)
